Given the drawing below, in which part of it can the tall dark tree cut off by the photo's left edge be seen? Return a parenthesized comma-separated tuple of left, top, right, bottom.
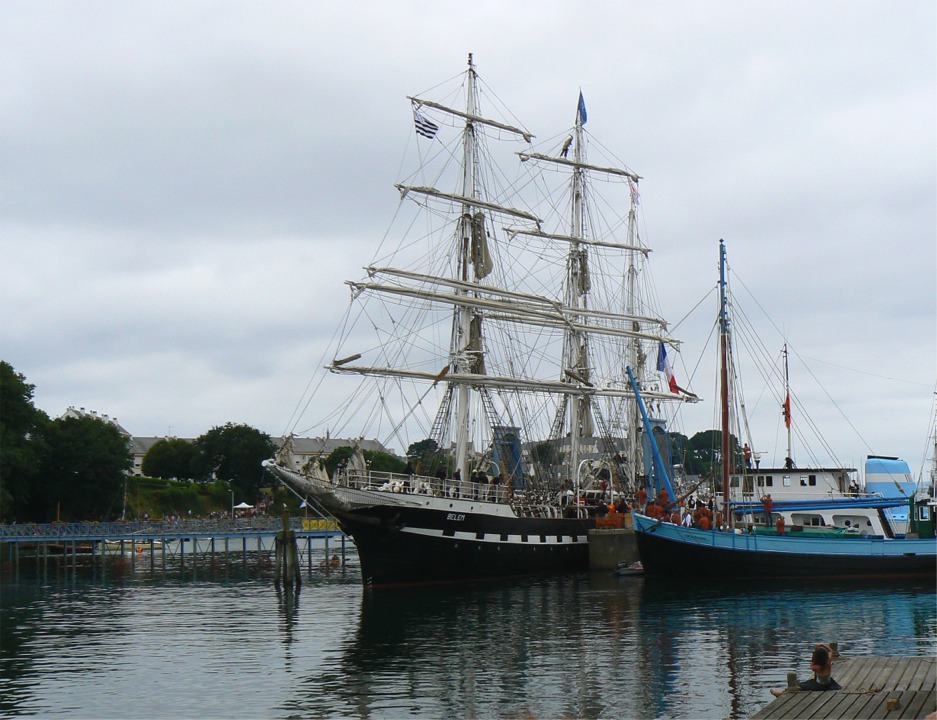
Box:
(0, 360, 49, 520)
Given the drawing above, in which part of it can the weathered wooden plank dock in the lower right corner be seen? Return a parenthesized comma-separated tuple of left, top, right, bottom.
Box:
(752, 657, 937, 720)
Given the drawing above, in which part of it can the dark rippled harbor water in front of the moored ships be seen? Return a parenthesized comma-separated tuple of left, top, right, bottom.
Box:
(0, 546, 937, 719)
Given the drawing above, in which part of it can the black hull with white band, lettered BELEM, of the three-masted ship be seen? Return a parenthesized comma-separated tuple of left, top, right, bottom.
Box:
(266, 468, 595, 586)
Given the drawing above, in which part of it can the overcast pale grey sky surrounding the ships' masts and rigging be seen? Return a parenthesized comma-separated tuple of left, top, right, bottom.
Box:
(0, 0, 937, 474)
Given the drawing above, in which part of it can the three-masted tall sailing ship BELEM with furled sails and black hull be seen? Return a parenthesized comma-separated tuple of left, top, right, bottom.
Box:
(265, 55, 691, 585)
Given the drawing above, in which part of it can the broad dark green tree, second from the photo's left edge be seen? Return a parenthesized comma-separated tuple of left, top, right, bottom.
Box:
(37, 417, 133, 521)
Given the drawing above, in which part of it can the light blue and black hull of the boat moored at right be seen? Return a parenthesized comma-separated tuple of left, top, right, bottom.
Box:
(635, 515, 937, 580)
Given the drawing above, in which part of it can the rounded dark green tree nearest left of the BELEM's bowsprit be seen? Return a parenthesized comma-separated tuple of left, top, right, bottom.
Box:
(195, 422, 276, 501)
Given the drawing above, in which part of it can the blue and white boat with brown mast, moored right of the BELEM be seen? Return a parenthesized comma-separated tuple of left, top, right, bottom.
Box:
(620, 245, 937, 579)
